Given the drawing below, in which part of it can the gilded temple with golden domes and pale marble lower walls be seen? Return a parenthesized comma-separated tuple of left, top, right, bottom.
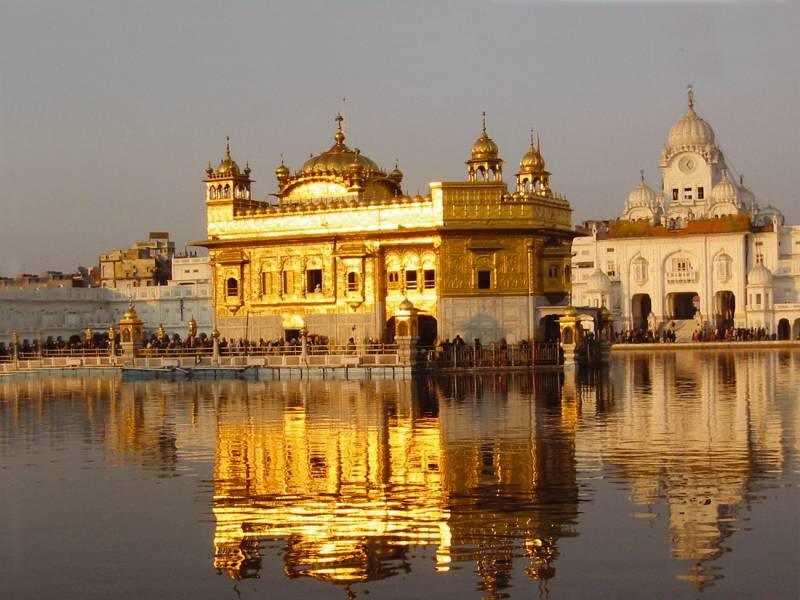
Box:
(197, 115, 574, 344)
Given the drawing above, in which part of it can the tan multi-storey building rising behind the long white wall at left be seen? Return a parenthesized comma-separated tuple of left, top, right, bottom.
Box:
(100, 231, 175, 288)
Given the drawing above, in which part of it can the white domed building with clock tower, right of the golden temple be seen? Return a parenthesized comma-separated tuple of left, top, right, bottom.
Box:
(572, 89, 800, 339)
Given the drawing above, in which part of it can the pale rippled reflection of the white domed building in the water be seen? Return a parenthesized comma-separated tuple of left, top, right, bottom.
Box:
(576, 351, 800, 588)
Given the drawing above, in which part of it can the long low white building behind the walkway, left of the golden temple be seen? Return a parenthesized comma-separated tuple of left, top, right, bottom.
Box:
(0, 257, 212, 343)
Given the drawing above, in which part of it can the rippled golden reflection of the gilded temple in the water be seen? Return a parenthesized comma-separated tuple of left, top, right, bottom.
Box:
(209, 379, 577, 591)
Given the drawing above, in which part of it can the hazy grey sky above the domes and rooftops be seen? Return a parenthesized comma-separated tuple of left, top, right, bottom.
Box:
(0, 0, 800, 277)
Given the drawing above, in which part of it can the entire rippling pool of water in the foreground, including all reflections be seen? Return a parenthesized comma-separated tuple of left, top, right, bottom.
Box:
(0, 350, 800, 600)
